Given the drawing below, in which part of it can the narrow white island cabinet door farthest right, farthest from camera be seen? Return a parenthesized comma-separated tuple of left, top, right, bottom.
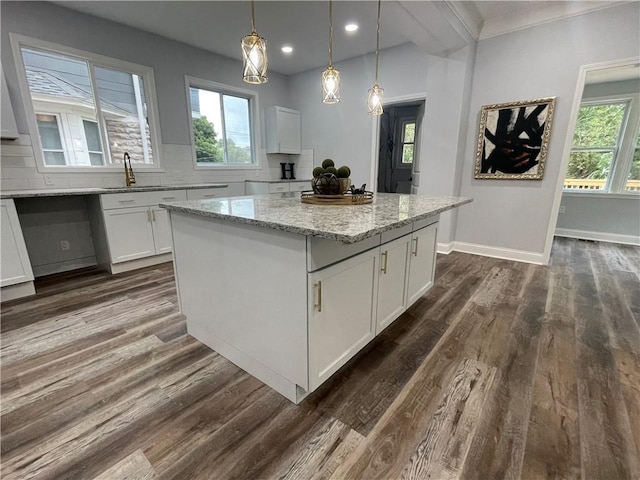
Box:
(407, 223, 438, 307)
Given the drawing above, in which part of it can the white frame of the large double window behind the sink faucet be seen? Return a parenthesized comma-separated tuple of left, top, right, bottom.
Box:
(9, 32, 165, 174)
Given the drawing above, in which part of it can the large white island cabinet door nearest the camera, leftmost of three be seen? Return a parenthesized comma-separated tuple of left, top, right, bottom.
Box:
(307, 248, 378, 391)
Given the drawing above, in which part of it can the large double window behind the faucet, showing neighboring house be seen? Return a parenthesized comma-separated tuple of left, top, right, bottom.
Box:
(12, 36, 158, 170)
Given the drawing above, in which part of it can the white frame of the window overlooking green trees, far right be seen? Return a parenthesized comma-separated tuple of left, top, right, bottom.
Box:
(562, 93, 640, 198)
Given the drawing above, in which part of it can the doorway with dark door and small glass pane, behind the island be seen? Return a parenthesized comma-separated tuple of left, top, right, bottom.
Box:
(377, 101, 424, 193)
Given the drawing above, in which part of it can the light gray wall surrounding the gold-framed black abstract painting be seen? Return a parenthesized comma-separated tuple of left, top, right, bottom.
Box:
(456, 3, 640, 261)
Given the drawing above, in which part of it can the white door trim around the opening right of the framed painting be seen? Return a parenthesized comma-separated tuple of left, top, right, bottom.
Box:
(542, 57, 640, 265)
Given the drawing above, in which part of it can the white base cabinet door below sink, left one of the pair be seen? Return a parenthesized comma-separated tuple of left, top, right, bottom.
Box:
(104, 207, 156, 263)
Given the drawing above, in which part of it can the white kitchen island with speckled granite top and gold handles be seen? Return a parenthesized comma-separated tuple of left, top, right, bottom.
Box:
(160, 193, 471, 403)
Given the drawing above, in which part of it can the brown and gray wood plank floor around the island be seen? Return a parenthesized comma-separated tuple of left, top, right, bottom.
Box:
(0, 239, 640, 480)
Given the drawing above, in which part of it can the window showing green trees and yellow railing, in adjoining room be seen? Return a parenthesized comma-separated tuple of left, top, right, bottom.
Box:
(564, 95, 640, 193)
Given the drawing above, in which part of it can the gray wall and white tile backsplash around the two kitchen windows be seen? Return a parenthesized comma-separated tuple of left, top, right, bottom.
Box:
(0, 1, 297, 190)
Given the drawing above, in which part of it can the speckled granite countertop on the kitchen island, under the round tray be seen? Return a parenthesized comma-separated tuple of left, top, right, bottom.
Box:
(160, 192, 472, 243)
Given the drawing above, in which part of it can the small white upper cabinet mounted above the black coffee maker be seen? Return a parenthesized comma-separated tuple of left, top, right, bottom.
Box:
(265, 107, 301, 154)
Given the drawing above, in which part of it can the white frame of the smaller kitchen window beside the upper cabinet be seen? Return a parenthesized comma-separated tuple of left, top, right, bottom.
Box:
(184, 75, 262, 171)
